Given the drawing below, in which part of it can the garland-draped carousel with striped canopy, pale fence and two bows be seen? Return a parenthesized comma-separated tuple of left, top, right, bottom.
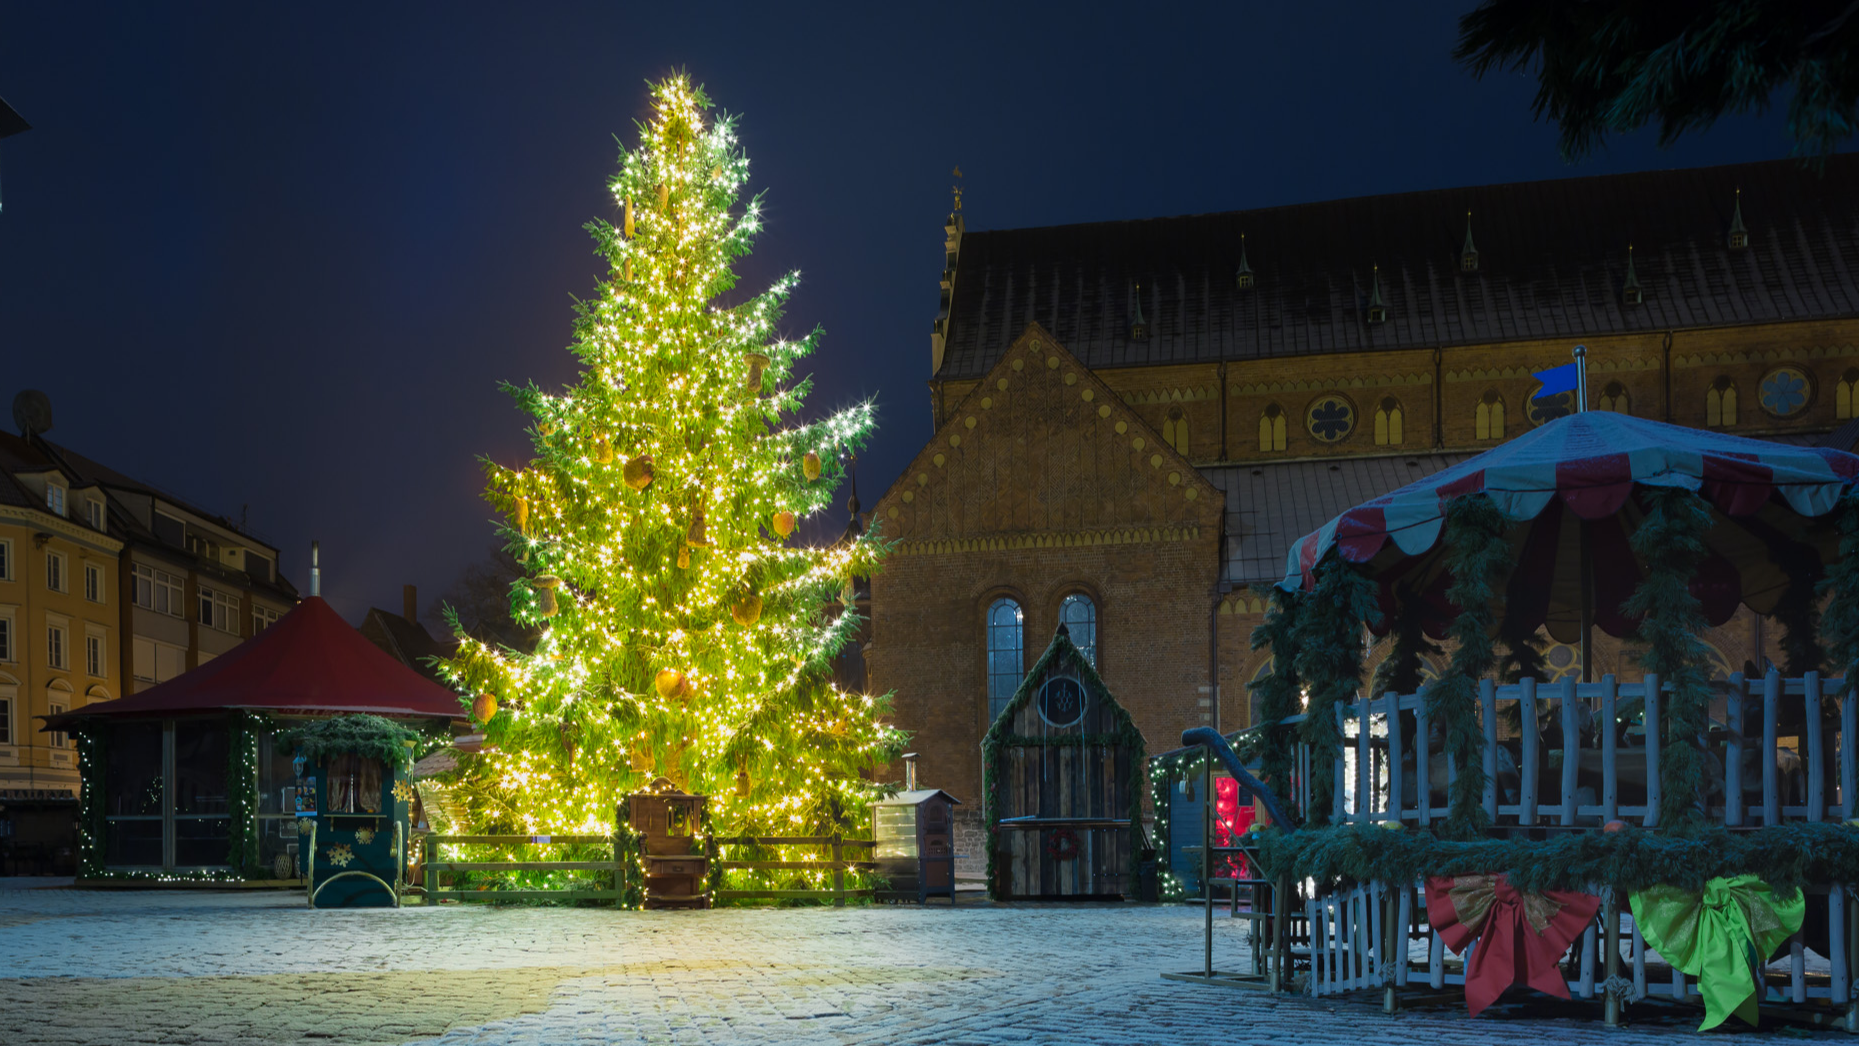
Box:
(1175, 403, 1859, 1031)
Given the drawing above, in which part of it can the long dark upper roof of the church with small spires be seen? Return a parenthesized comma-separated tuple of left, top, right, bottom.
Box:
(935, 154, 1859, 379)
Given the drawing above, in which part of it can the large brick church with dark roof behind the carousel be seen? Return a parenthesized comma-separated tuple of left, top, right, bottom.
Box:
(864, 156, 1859, 828)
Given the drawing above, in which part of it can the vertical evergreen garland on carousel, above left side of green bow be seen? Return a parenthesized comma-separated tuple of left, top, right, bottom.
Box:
(1623, 487, 1710, 829)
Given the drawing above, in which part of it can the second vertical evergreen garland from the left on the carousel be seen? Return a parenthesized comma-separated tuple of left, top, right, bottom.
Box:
(1296, 550, 1381, 825)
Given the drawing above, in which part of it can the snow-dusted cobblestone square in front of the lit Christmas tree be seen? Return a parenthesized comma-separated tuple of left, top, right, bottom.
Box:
(0, 881, 1814, 1046)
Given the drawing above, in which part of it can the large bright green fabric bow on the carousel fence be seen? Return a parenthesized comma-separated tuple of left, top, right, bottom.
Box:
(1630, 875, 1807, 1031)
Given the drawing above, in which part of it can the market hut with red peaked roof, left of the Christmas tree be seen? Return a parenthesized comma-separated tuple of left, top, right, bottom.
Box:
(46, 596, 463, 881)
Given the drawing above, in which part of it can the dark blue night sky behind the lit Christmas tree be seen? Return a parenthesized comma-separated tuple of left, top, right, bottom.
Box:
(0, 0, 1788, 621)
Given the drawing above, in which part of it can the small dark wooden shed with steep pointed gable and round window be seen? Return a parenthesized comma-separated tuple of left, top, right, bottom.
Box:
(982, 624, 1145, 901)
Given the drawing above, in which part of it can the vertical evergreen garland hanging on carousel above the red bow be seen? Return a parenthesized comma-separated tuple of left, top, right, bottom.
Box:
(1426, 494, 1511, 838)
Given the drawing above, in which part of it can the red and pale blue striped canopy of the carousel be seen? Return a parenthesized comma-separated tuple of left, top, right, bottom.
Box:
(1279, 411, 1859, 643)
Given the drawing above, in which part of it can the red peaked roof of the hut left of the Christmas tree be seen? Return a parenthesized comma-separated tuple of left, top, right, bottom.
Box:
(46, 596, 461, 726)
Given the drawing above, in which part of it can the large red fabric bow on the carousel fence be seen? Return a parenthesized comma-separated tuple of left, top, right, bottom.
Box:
(1426, 875, 1601, 1016)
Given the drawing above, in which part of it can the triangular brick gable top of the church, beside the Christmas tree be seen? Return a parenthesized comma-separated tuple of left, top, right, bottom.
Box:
(877, 325, 1223, 544)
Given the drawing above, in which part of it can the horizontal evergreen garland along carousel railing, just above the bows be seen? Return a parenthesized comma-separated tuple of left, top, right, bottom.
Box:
(1260, 821, 1859, 894)
